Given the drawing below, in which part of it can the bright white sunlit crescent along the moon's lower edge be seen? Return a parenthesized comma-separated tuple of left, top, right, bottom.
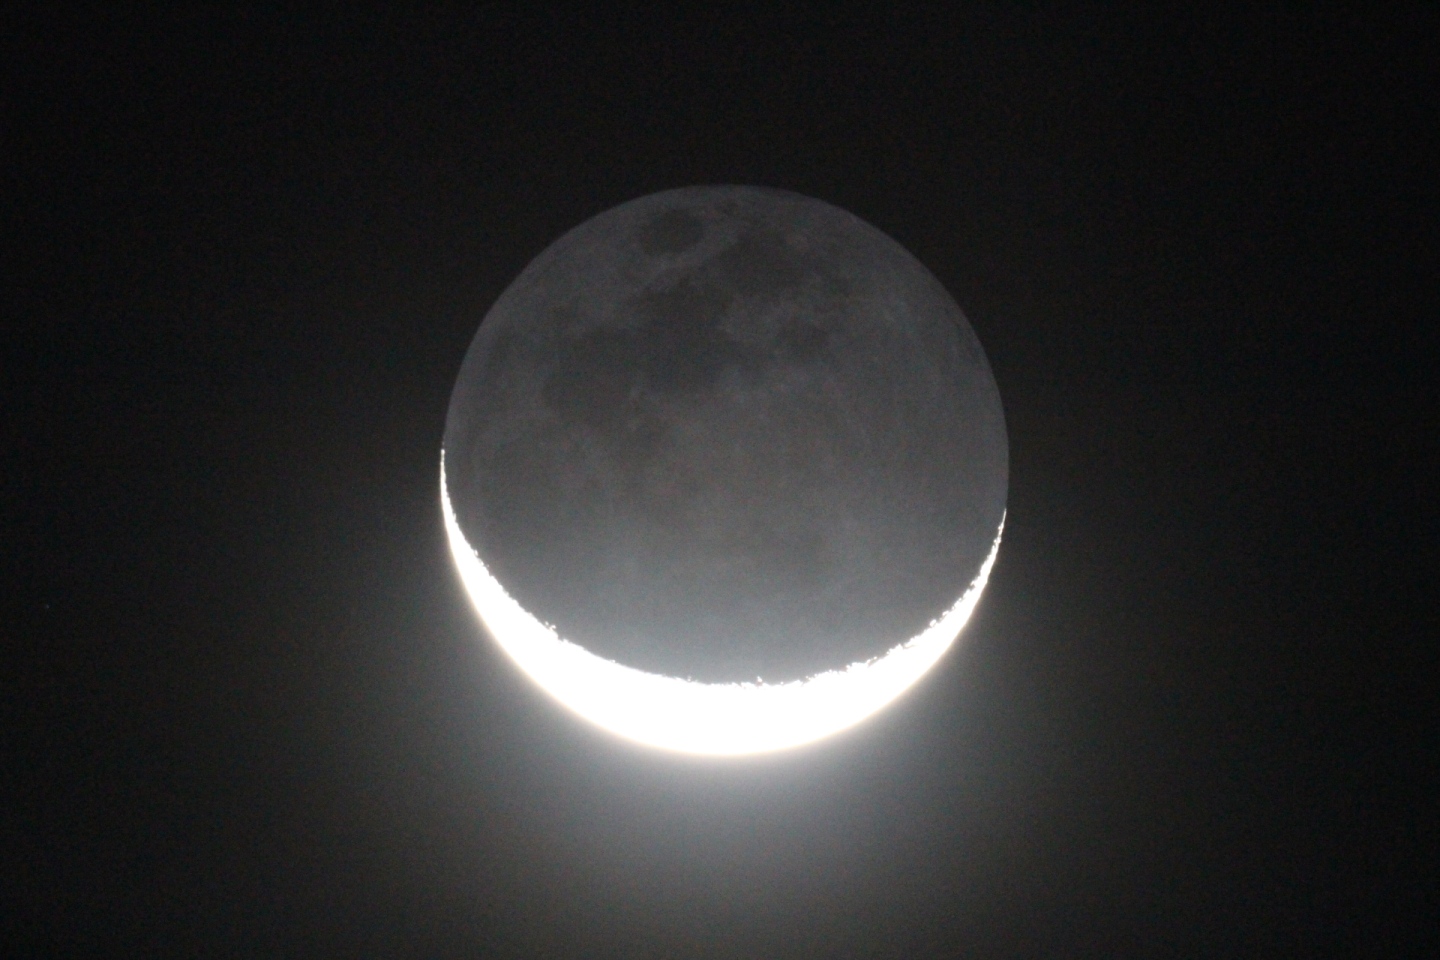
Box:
(441, 453, 1005, 756)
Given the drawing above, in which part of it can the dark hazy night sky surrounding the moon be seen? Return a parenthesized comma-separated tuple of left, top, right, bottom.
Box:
(0, 4, 1440, 959)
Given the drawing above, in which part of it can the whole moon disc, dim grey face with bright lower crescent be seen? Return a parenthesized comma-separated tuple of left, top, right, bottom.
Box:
(441, 186, 1008, 754)
